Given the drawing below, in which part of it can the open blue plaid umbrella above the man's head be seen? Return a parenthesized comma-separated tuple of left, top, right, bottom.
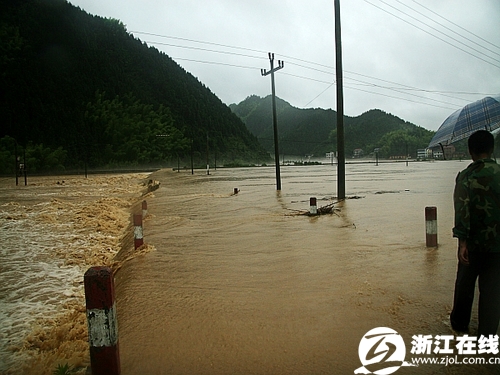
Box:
(429, 95, 500, 148)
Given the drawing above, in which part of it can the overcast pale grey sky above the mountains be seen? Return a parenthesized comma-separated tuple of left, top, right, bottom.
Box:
(69, 0, 500, 130)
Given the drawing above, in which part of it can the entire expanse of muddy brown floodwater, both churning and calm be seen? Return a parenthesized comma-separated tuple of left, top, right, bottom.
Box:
(0, 161, 500, 375)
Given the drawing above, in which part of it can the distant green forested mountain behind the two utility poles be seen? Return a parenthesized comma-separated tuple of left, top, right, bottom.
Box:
(230, 96, 434, 157)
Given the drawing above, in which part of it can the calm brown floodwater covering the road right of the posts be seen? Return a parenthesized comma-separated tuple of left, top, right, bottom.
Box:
(112, 161, 499, 375)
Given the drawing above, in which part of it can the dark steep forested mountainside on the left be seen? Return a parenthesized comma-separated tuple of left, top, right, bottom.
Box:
(0, 0, 269, 173)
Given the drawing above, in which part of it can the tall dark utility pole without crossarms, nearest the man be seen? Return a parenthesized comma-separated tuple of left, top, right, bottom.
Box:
(334, 0, 345, 200)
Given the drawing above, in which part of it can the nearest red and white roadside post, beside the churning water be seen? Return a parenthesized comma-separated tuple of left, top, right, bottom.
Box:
(84, 267, 121, 375)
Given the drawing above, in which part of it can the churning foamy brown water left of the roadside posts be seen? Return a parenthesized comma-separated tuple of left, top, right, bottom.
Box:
(0, 173, 152, 375)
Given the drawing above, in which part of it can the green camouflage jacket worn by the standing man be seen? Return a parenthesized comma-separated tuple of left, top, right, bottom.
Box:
(453, 159, 500, 252)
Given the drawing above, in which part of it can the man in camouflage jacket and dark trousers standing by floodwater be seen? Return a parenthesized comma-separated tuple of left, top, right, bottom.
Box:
(450, 130, 500, 336)
